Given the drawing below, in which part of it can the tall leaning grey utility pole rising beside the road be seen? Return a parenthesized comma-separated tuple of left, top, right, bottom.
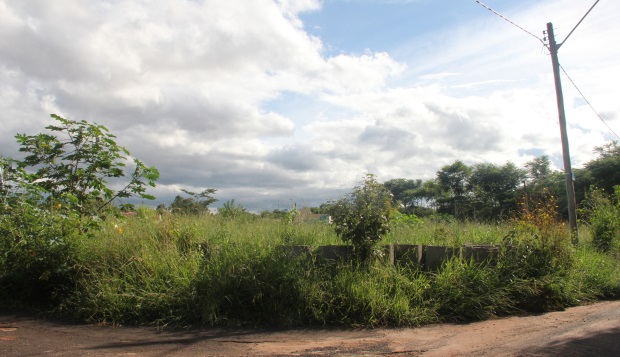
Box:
(547, 23, 580, 244)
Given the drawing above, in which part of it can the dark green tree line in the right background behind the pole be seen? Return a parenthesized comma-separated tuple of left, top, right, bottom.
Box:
(383, 141, 620, 221)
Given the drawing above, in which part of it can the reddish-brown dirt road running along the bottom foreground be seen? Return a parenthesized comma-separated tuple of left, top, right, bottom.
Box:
(0, 301, 620, 357)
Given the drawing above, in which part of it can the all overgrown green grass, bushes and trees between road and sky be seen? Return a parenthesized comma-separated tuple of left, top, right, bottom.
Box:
(0, 118, 620, 327)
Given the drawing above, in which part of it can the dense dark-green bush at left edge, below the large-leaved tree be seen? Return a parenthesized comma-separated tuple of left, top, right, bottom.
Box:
(0, 198, 83, 305)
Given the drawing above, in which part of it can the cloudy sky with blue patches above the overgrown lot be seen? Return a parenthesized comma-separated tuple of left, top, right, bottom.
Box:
(0, 0, 620, 212)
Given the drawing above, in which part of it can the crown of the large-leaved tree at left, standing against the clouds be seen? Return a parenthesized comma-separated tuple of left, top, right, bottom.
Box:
(15, 114, 159, 216)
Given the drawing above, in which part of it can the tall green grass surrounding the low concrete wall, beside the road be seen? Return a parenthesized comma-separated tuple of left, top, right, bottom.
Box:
(3, 209, 620, 327)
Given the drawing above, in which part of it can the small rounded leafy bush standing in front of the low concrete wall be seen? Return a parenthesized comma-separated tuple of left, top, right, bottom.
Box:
(329, 174, 392, 261)
